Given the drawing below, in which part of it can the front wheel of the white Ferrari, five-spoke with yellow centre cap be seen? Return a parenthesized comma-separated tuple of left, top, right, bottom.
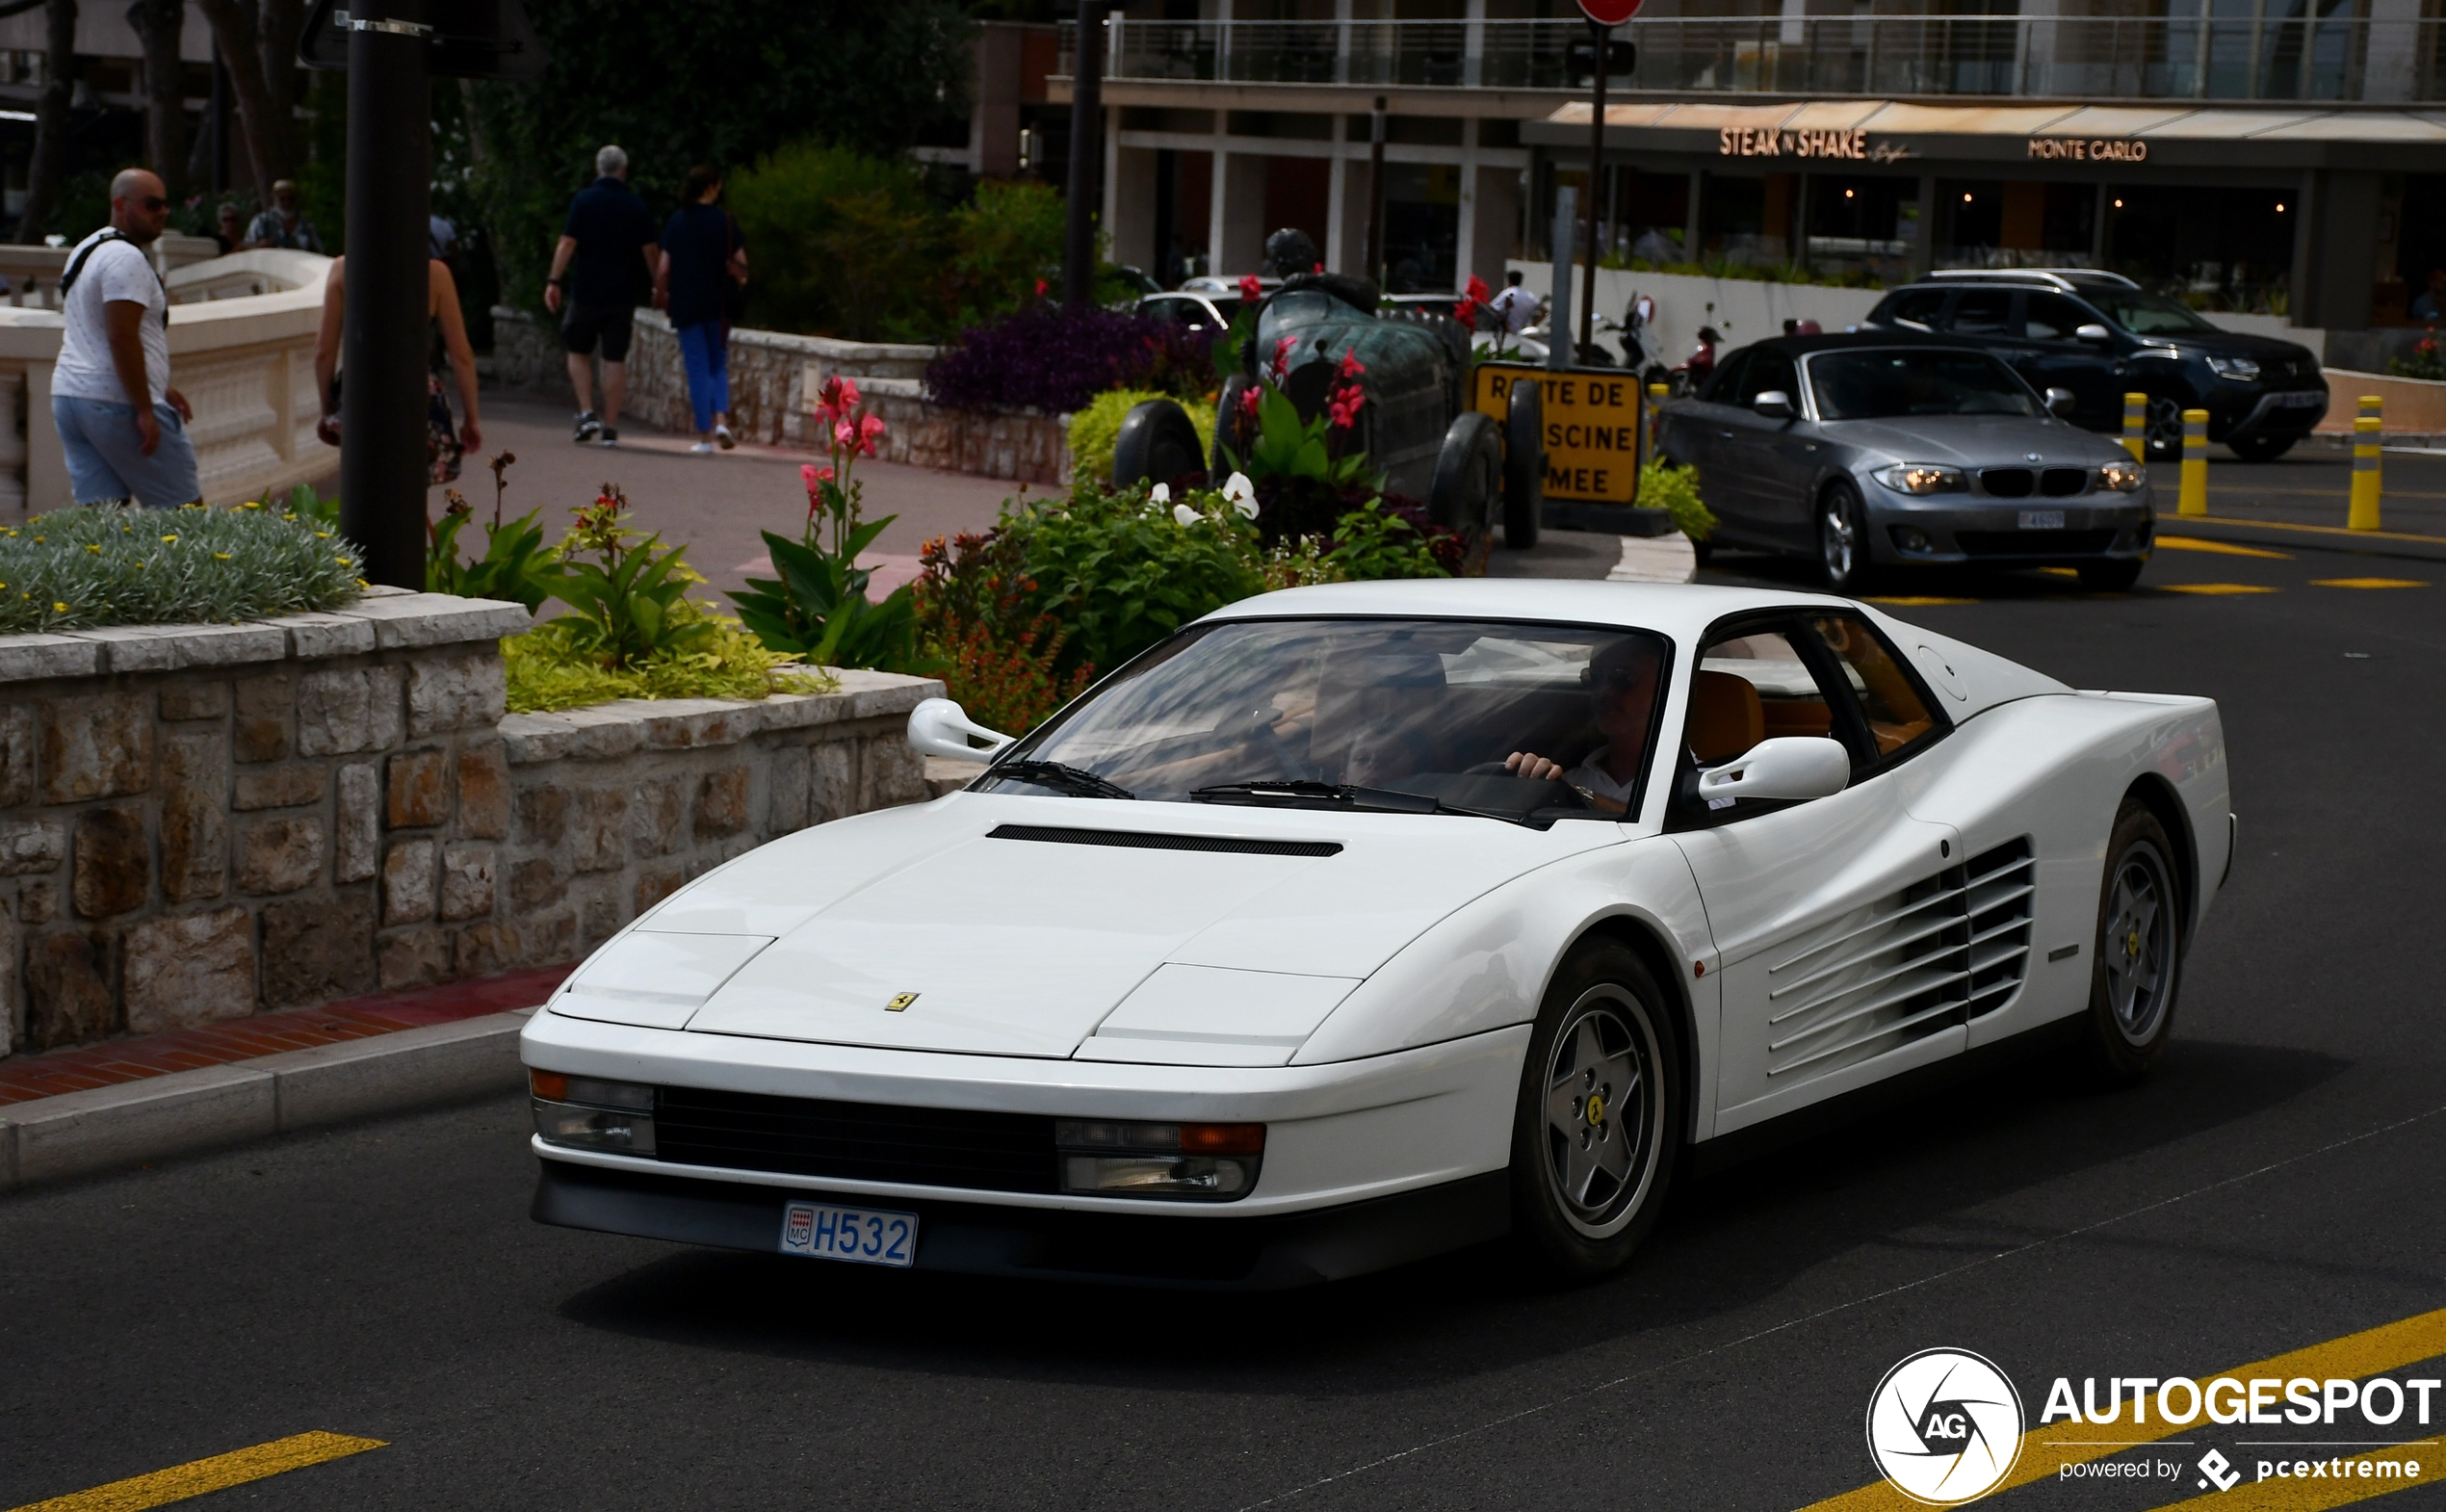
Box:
(1512, 942, 1683, 1280)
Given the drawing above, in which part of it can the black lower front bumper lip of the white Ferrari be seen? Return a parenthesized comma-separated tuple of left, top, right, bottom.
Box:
(533, 1160, 1512, 1291)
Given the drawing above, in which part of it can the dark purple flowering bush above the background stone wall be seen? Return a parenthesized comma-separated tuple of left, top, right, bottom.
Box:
(924, 303, 1213, 413)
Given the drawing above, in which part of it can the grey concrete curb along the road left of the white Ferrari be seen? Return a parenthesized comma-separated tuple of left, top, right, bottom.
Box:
(0, 1008, 533, 1191)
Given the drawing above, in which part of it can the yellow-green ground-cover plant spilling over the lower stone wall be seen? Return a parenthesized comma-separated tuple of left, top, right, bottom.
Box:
(502, 599, 839, 715)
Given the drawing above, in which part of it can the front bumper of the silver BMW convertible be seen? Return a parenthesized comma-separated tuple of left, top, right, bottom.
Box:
(1861, 480, 2157, 567)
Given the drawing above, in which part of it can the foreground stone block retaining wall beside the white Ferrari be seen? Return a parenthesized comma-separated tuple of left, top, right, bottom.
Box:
(0, 589, 942, 1055)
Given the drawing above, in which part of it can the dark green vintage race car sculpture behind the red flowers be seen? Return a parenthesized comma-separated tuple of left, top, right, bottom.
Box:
(1113, 254, 1546, 548)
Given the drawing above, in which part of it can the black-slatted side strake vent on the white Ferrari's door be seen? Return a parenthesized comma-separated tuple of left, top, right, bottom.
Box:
(1766, 839, 2038, 1077)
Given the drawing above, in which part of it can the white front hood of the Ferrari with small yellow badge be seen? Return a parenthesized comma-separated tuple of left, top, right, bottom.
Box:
(574, 793, 1625, 1064)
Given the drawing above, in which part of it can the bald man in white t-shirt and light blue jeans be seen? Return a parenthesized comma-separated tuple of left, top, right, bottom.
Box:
(51, 169, 203, 508)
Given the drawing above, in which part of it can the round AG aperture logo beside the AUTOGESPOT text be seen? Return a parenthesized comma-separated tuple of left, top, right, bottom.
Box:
(1869, 1348, 2020, 1507)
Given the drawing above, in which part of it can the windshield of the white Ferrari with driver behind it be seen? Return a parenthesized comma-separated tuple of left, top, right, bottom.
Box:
(988, 619, 1666, 822)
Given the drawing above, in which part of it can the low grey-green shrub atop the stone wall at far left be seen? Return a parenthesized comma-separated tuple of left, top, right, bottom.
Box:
(0, 504, 364, 634)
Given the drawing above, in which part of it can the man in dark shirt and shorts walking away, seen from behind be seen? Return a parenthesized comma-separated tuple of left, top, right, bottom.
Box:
(543, 146, 661, 445)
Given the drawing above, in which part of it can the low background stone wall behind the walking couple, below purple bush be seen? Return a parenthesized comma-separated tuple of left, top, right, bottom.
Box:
(492, 306, 1069, 487)
